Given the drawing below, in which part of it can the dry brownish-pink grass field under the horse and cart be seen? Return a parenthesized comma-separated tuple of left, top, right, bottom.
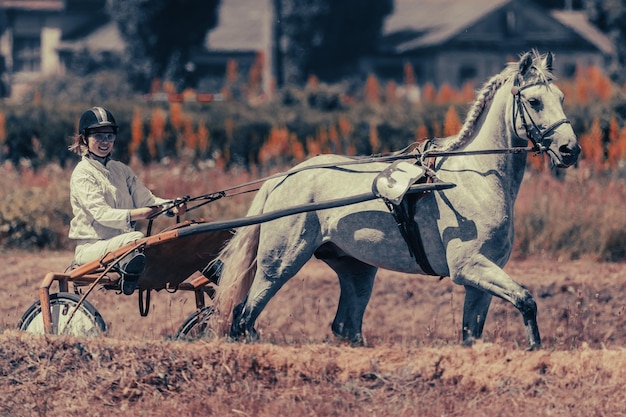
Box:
(0, 251, 626, 417)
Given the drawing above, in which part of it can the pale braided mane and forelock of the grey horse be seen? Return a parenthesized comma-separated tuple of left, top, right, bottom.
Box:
(442, 50, 553, 151)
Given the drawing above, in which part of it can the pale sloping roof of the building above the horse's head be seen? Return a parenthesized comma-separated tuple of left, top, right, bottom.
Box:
(383, 0, 511, 53)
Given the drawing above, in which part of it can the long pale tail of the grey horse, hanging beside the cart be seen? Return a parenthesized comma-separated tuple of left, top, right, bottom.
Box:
(214, 186, 269, 334)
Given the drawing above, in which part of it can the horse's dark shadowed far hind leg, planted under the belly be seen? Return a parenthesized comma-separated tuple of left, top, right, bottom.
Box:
(324, 256, 378, 345)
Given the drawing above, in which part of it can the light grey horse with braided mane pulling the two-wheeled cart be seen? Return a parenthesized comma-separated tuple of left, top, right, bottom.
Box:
(215, 50, 581, 349)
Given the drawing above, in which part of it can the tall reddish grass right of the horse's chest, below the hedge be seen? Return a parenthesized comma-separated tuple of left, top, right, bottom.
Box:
(515, 168, 626, 261)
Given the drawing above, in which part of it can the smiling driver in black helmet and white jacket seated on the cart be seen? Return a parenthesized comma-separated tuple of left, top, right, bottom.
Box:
(69, 107, 186, 295)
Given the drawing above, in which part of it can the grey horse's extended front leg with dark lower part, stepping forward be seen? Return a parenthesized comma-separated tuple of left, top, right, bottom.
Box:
(451, 255, 541, 350)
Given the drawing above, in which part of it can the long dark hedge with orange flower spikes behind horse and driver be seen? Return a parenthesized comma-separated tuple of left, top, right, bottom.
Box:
(0, 64, 626, 174)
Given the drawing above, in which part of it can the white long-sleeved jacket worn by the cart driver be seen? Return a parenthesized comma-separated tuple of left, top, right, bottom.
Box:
(69, 157, 169, 243)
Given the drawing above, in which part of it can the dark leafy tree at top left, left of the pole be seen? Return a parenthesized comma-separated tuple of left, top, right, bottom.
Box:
(107, 0, 220, 91)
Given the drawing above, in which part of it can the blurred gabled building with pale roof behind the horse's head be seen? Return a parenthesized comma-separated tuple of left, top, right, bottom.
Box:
(362, 0, 615, 87)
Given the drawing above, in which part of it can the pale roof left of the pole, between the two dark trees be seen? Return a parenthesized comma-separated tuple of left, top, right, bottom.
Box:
(205, 0, 273, 51)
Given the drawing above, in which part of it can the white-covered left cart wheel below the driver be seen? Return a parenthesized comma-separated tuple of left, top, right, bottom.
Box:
(17, 292, 106, 336)
